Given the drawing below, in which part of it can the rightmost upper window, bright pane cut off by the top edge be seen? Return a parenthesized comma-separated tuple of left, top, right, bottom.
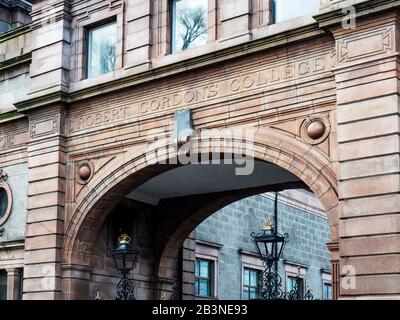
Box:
(274, 0, 320, 22)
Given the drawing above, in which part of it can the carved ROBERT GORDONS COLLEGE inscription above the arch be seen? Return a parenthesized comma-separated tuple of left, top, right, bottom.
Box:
(67, 51, 334, 133)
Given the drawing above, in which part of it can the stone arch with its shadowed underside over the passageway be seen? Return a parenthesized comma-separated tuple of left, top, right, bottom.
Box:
(63, 128, 338, 298)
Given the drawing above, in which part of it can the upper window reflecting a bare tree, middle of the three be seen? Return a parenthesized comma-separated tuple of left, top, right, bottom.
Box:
(171, 0, 208, 52)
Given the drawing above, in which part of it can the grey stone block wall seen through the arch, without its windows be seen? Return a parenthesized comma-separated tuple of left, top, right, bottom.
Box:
(196, 195, 331, 300)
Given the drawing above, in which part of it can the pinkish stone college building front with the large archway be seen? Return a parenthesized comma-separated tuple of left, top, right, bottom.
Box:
(0, 0, 400, 299)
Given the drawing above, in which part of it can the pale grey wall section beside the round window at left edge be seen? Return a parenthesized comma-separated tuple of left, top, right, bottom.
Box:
(0, 164, 28, 244)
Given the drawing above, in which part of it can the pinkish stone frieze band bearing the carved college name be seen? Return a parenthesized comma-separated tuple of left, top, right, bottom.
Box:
(67, 49, 334, 134)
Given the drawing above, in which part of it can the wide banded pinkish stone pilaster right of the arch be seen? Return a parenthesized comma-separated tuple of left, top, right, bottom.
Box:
(333, 12, 400, 299)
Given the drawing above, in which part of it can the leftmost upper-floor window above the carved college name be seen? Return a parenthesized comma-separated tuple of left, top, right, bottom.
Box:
(87, 22, 117, 78)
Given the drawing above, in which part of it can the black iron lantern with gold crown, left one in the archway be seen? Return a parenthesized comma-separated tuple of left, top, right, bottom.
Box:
(111, 234, 139, 300)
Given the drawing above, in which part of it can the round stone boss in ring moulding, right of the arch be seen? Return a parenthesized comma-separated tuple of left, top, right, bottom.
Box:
(300, 116, 331, 145)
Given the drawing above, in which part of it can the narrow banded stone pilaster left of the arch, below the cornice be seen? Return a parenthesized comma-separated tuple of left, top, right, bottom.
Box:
(23, 106, 65, 299)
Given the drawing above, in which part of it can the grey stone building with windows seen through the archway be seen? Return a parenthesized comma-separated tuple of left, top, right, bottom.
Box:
(194, 190, 332, 300)
